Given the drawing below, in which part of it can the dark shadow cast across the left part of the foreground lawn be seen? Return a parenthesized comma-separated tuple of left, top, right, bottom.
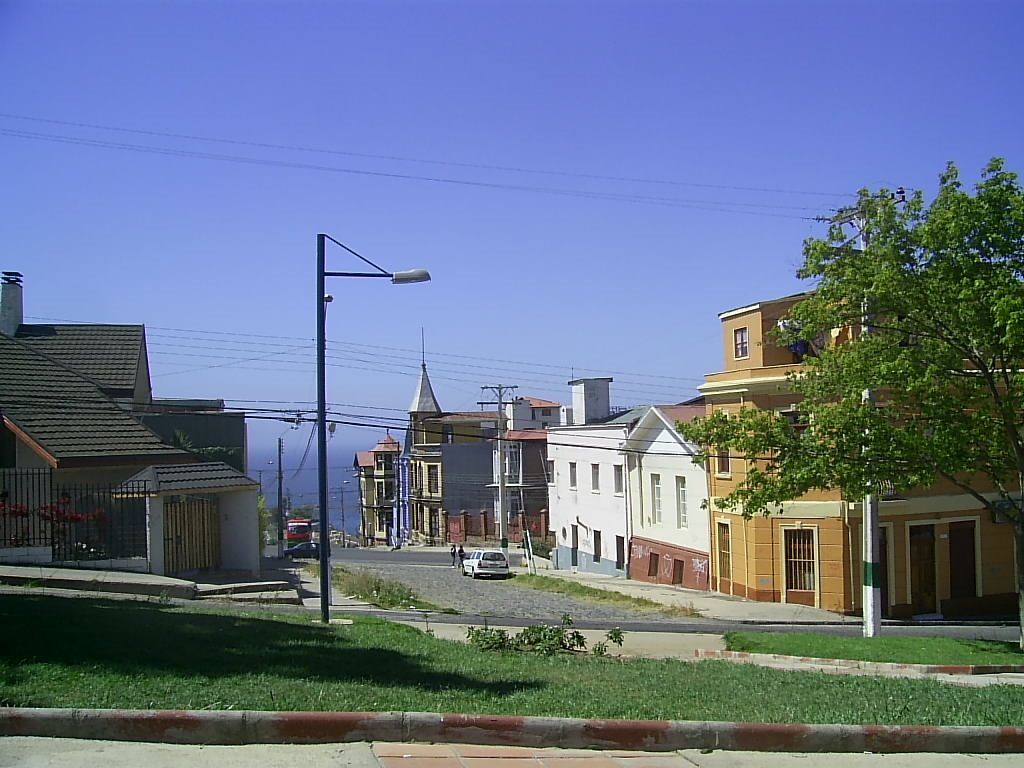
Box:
(0, 595, 540, 694)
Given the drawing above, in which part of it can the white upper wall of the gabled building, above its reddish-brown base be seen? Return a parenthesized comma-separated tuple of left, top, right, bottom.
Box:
(626, 412, 711, 552)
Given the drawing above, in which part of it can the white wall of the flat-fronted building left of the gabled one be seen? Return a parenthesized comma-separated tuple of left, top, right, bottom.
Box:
(548, 424, 629, 569)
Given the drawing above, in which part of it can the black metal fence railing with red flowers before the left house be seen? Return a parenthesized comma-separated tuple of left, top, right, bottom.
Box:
(0, 469, 146, 562)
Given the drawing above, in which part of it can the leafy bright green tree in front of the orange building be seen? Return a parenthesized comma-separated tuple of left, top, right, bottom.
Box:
(679, 160, 1024, 648)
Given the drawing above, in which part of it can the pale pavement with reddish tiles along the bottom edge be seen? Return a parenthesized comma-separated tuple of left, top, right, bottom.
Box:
(0, 736, 1020, 768)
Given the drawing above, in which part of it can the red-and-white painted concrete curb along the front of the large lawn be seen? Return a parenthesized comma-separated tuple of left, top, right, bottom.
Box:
(0, 708, 1024, 754)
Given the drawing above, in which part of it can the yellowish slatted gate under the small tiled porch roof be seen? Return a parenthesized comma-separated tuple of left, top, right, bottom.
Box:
(164, 497, 220, 575)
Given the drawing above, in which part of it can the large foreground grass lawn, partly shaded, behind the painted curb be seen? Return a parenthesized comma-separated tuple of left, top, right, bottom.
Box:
(0, 592, 1024, 725)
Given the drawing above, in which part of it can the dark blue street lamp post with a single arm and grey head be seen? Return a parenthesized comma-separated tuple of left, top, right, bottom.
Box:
(316, 232, 430, 624)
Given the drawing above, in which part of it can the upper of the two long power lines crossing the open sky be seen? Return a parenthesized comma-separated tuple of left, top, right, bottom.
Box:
(0, 113, 851, 198)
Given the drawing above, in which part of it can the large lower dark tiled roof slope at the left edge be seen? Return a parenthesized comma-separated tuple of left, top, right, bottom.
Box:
(0, 334, 189, 466)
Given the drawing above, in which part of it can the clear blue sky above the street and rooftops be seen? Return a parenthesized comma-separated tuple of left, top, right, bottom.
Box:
(0, 0, 1024, 479)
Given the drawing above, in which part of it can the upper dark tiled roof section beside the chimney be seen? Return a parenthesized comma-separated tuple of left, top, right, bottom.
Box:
(14, 324, 145, 391)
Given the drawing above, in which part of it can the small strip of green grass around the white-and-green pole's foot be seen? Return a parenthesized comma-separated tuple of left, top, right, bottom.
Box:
(725, 632, 1024, 665)
